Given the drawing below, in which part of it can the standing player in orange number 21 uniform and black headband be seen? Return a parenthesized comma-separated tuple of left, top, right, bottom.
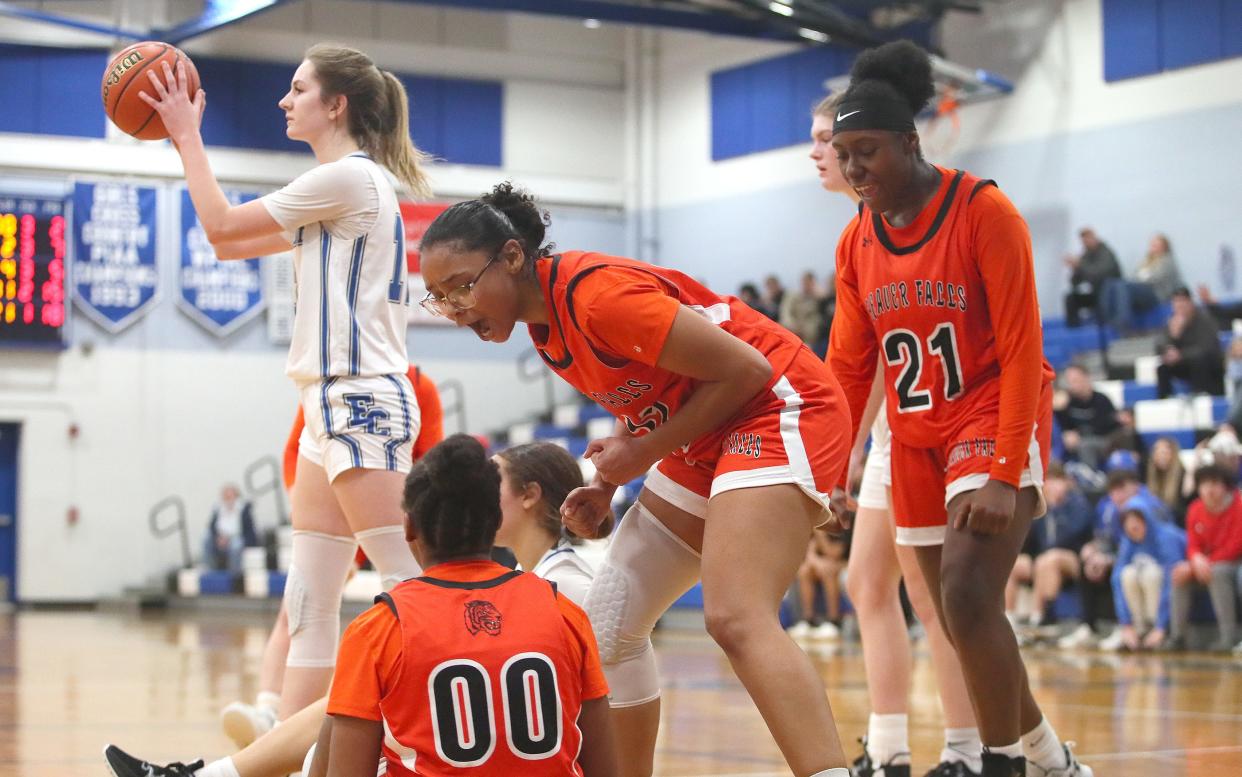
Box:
(828, 41, 1092, 777)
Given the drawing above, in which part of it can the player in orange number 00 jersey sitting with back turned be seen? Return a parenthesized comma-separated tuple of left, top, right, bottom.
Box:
(311, 434, 616, 777)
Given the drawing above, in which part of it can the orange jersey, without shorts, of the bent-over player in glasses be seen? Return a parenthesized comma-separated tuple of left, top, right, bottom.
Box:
(529, 251, 804, 459)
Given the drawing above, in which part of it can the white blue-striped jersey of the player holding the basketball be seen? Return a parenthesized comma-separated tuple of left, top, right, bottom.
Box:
(262, 151, 410, 384)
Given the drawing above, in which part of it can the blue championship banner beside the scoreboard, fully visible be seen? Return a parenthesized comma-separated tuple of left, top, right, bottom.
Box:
(70, 182, 159, 334)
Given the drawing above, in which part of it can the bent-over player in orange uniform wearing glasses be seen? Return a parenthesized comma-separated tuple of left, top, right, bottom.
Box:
(422, 184, 850, 777)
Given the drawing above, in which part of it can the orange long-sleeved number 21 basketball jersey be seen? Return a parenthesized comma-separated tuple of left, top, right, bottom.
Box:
(828, 168, 1053, 485)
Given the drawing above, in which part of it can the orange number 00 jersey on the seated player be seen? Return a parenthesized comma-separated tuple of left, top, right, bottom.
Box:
(328, 561, 607, 777)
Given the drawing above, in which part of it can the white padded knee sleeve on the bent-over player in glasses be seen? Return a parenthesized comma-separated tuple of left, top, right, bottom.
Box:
(585, 503, 699, 707)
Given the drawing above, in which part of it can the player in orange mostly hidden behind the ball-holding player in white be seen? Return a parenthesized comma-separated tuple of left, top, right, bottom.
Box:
(220, 364, 445, 747)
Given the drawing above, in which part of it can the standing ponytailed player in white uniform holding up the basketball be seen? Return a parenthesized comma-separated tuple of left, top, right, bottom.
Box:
(143, 45, 427, 719)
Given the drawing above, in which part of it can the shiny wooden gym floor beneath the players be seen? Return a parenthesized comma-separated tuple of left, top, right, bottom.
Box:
(0, 612, 1242, 777)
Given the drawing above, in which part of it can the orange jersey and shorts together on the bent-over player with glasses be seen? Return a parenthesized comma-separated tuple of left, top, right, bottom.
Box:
(529, 251, 845, 501)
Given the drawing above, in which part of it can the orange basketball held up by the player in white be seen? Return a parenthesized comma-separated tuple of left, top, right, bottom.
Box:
(99, 41, 199, 140)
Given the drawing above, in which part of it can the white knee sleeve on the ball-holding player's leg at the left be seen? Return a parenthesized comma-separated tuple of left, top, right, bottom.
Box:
(284, 531, 355, 668)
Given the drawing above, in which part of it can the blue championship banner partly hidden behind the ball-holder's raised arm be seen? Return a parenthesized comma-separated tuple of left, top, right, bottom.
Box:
(176, 190, 265, 338)
